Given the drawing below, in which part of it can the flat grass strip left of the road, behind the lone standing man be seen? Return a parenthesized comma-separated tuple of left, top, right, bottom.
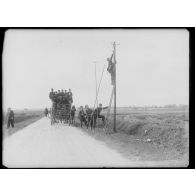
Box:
(3, 110, 44, 138)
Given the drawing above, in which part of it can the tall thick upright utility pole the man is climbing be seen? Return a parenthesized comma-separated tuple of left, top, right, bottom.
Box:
(113, 42, 116, 132)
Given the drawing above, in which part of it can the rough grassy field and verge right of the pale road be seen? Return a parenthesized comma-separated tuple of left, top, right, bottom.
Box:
(76, 108, 189, 160)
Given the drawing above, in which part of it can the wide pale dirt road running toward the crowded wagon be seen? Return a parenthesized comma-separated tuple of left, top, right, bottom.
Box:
(3, 118, 186, 168)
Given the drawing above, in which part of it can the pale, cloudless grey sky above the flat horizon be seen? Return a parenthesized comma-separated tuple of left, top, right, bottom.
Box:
(3, 29, 189, 109)
